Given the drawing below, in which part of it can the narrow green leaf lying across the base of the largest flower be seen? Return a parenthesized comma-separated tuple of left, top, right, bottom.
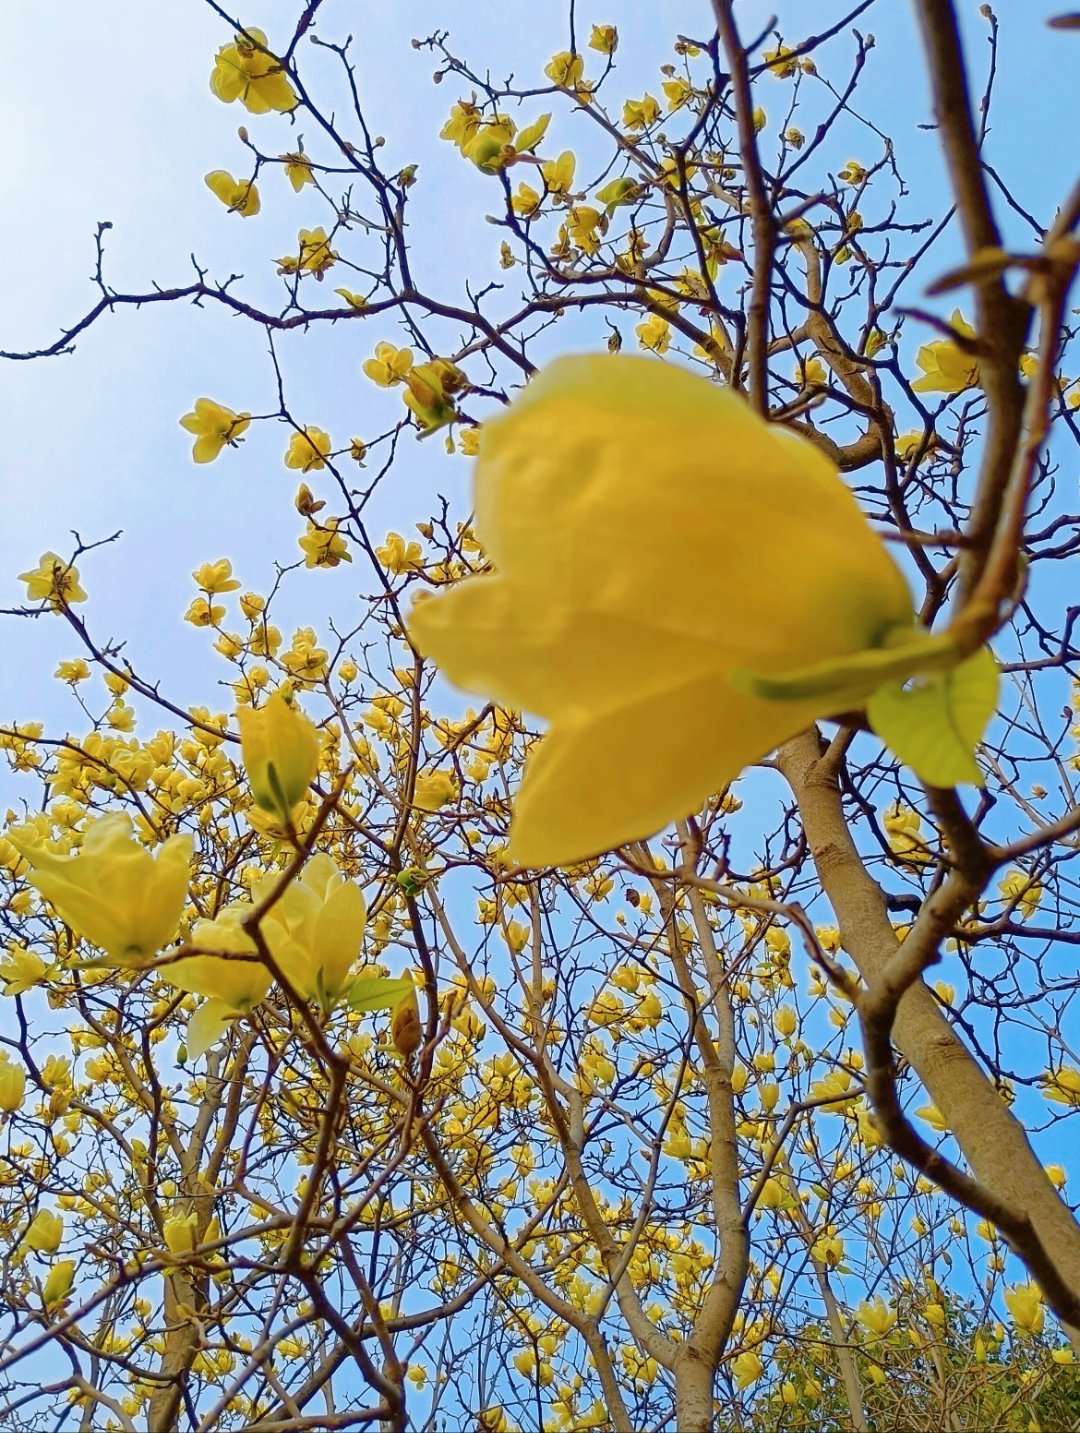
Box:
(728, 628, 957, 714)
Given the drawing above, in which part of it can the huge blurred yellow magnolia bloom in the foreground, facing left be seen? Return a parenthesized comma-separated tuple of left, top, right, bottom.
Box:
(410, 355, 912, 866)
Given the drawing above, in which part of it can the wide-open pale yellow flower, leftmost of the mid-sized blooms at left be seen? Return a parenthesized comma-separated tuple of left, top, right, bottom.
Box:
(13, 814, 192, 969)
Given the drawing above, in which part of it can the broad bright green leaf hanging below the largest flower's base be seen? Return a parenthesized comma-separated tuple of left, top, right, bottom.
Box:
(867, 648, 998, 787)
